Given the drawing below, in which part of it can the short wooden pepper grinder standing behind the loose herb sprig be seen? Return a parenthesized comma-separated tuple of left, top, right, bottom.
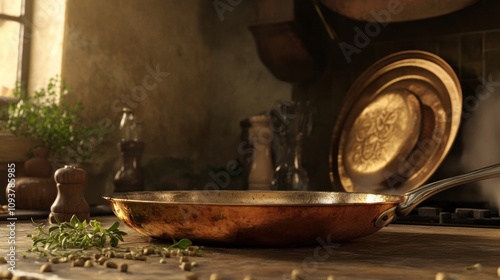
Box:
(49, 165, 90, 223)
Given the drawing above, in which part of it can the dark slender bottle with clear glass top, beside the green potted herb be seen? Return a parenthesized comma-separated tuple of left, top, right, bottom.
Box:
(114, 108, 144, 192)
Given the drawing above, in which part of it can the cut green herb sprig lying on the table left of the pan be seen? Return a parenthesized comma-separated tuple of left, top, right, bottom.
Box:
(28, 215, 127, 256)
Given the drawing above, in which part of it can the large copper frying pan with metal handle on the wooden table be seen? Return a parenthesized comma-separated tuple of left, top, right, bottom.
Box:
(104, 164, 500, 246)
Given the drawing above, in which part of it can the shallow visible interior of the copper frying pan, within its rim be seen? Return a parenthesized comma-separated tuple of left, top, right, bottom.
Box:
(104, 191, 404, 206)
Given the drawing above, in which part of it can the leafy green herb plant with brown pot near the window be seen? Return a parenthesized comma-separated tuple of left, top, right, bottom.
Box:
(4, 76, 99, 210)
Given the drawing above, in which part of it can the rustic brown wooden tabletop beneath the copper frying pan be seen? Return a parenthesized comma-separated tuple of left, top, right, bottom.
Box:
(0, 217, 500, 280)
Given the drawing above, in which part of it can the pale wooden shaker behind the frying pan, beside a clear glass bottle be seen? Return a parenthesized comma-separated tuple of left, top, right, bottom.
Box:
(248, 115, 274, 190)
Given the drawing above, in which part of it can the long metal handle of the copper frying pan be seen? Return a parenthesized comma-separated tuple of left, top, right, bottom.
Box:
(396, 163, 500, 216)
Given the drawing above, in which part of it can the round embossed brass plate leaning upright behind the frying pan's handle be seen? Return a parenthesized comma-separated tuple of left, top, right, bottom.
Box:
(330, 50, 462, 194)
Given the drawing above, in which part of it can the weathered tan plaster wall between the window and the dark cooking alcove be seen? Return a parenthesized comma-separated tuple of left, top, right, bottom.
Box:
(62, 0, 291, 203)
